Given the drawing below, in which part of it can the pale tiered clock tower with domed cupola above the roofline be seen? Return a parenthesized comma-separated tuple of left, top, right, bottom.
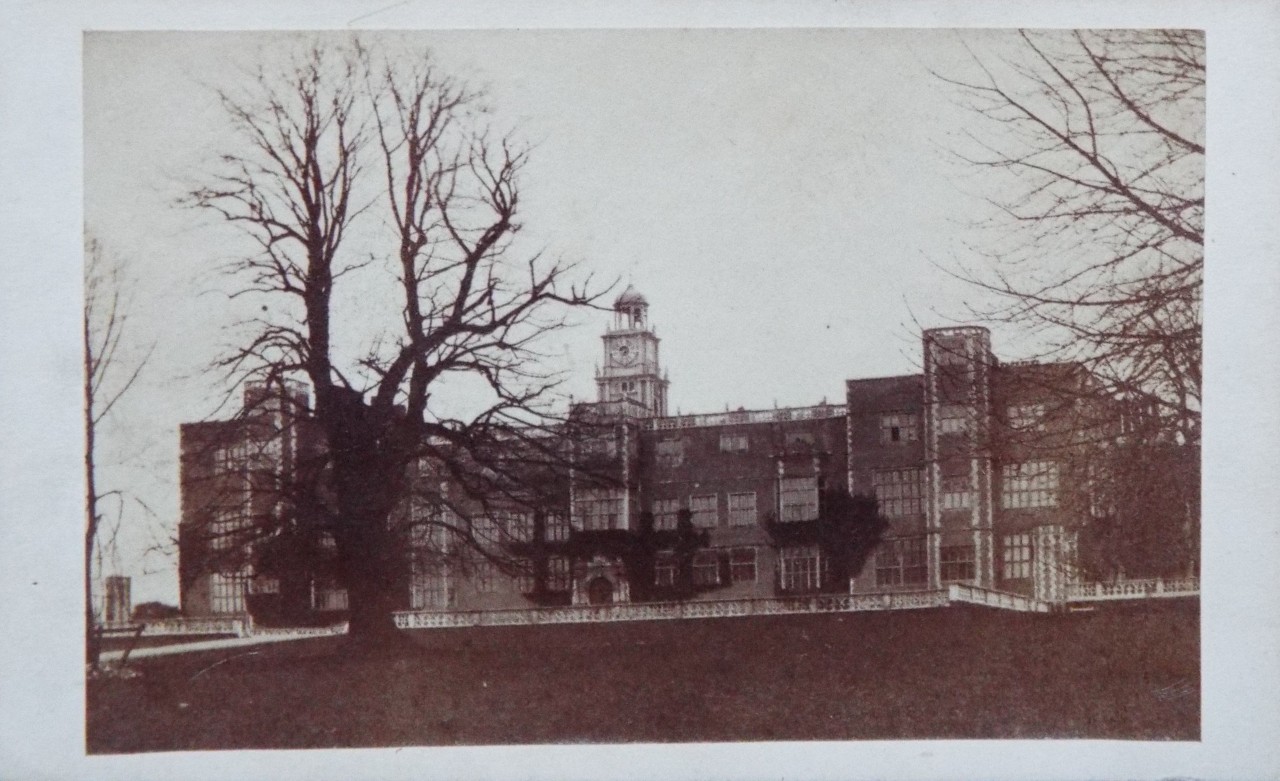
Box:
(595, 286, 667, 417)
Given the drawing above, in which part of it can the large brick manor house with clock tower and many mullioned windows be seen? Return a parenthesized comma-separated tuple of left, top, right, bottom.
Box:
(179, 287, 1141, 616)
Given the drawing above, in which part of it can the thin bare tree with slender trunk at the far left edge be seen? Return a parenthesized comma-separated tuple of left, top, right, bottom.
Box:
(82, 237, 150, 666)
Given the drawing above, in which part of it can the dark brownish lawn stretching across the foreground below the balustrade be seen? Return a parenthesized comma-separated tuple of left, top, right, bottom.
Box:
(87, 600, 1199, 753)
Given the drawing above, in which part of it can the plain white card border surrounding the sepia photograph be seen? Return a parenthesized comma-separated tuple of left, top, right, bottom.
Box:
(0, 0, 1280, 780)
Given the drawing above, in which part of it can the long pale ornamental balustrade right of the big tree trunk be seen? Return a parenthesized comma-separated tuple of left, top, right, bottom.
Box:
(396, 584, 1050, 629)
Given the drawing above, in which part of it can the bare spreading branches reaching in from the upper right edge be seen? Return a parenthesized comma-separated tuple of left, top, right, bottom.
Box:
(937, 29, 1204, 442)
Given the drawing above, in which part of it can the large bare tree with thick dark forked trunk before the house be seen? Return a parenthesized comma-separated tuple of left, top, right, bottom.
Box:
(189, 41, 596, 640)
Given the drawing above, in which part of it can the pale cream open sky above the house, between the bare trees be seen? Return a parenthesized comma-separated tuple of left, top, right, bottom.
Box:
(84, 29, 1016, 602)
